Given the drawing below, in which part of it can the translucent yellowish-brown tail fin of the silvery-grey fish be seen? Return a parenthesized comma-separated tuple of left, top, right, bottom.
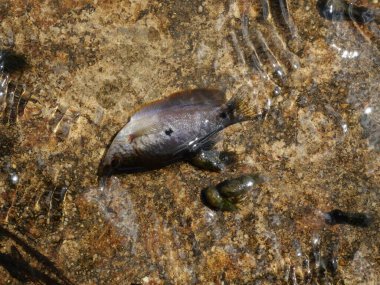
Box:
(227, 87, 262, 122)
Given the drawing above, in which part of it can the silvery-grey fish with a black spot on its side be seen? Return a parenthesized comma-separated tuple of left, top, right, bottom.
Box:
(98, 89, 258, 177)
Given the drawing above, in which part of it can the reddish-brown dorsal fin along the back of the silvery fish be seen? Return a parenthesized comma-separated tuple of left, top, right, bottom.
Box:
(131, 89, 226, 120)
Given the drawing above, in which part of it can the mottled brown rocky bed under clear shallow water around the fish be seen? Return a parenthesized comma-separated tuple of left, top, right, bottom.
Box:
(0, 0, 380, 284)
